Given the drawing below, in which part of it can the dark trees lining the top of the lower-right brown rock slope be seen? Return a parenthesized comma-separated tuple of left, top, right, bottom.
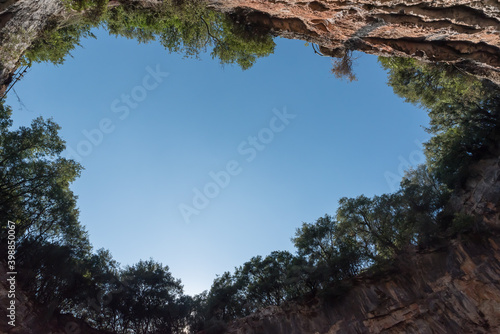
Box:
(188, 160, 459, 331)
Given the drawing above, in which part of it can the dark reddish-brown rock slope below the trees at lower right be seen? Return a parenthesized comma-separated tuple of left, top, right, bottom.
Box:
(228, 235, 500, 334)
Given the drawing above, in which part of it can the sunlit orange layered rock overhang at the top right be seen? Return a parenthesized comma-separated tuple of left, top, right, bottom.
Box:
(209, 0, 500, 83)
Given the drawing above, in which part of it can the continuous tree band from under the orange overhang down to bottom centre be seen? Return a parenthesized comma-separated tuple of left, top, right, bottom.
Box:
(189, 58, 500, 330)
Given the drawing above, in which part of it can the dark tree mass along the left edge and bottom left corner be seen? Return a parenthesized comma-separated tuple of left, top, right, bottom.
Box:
(0, 103, 194, 333)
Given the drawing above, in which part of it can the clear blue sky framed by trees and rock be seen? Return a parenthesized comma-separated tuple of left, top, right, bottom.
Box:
(7, 30, 428, 294)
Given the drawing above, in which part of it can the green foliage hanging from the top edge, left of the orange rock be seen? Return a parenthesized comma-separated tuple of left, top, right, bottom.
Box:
(105, 1, 274, 69)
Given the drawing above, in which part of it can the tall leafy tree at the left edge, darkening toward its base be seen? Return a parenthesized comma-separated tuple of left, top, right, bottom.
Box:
(0, 101, 91, 320)
